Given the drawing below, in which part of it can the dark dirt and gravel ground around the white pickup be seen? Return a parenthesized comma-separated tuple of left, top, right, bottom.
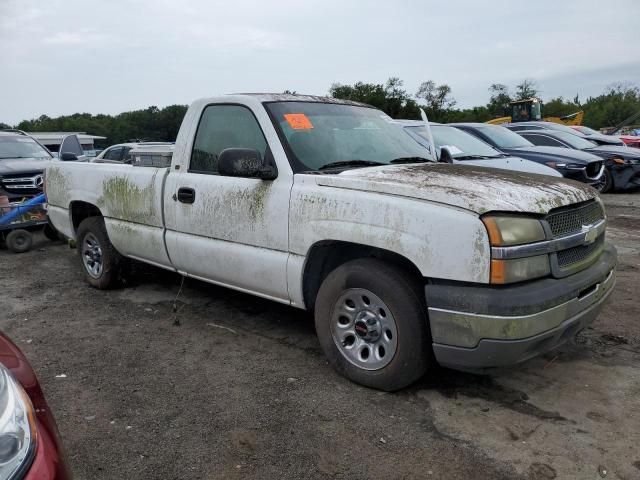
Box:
(0, 193, 640, 480)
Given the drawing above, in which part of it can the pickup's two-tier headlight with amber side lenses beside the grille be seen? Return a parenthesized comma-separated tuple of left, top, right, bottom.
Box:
(482, 215, 551, 284)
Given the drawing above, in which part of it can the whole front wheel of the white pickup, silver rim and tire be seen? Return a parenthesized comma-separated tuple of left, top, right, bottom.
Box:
(315, 258, 432, 391)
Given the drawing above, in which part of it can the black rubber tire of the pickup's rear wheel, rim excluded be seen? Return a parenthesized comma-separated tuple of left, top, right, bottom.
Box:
(76, 217, 124, 290)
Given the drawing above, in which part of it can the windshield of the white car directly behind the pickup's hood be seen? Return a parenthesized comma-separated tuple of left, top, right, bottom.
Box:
(405, 125, 501, 160)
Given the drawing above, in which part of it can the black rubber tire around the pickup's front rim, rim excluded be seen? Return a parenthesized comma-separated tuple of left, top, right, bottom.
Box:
(315, 258, 435, 391)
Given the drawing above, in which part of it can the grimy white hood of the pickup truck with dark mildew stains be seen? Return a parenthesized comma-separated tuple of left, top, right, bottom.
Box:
(316, 163, 597, 214)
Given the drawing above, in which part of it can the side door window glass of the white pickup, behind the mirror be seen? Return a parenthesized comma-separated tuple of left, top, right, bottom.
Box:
(189, 105, 267, 173)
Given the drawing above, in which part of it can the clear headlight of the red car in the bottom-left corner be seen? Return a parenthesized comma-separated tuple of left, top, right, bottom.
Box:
(0, 365, 36, 480)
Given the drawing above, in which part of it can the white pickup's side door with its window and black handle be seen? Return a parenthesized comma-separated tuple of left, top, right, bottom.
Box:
(165, 104, 293, 303)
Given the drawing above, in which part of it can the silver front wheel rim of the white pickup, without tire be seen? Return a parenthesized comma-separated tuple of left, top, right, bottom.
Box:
(331, 288, 398, 370)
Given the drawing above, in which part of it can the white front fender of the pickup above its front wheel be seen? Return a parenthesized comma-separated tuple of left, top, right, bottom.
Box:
(289, 184, 490, 283)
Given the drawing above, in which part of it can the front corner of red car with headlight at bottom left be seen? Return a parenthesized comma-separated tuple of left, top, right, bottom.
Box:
(0, 332, 71, 480)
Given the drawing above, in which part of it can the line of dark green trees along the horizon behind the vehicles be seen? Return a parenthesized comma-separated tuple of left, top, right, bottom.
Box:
(0, 77, 640, 146)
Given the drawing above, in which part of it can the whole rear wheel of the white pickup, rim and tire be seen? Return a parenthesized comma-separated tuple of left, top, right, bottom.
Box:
(76, 217, 123, 290)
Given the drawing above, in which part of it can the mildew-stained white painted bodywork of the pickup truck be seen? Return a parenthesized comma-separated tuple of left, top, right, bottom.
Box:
(47, 95, 595, 307)
